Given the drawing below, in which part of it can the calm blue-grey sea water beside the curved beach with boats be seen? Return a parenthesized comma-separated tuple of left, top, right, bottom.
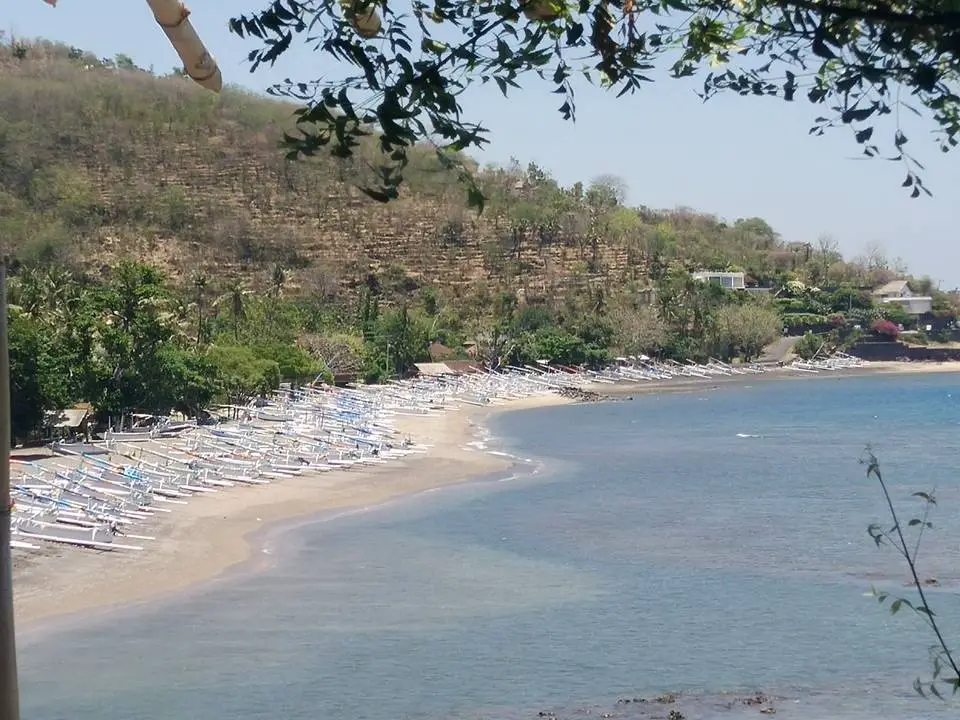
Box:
(21, 376, 960, 720)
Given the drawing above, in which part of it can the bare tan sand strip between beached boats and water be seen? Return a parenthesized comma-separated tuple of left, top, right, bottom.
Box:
(14, 395, 570, 630)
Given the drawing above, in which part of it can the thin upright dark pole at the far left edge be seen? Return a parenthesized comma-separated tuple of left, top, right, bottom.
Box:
(0, 258, 20, 720)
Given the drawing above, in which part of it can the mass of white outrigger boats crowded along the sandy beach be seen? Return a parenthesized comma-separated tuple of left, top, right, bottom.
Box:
(3, 356, 864, 551)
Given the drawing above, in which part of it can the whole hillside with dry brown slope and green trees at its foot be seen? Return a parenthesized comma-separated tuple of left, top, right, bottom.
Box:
(0, 42, 957, 439)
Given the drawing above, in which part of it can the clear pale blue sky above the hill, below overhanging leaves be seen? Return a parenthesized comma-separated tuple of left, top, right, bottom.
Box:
(7, 0, 960, 290)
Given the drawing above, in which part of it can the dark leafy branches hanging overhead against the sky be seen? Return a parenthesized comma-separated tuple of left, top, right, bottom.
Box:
(230, 0, 960, 201)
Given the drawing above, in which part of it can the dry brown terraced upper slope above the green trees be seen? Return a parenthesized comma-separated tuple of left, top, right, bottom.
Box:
(0, 37, 840, 296)
